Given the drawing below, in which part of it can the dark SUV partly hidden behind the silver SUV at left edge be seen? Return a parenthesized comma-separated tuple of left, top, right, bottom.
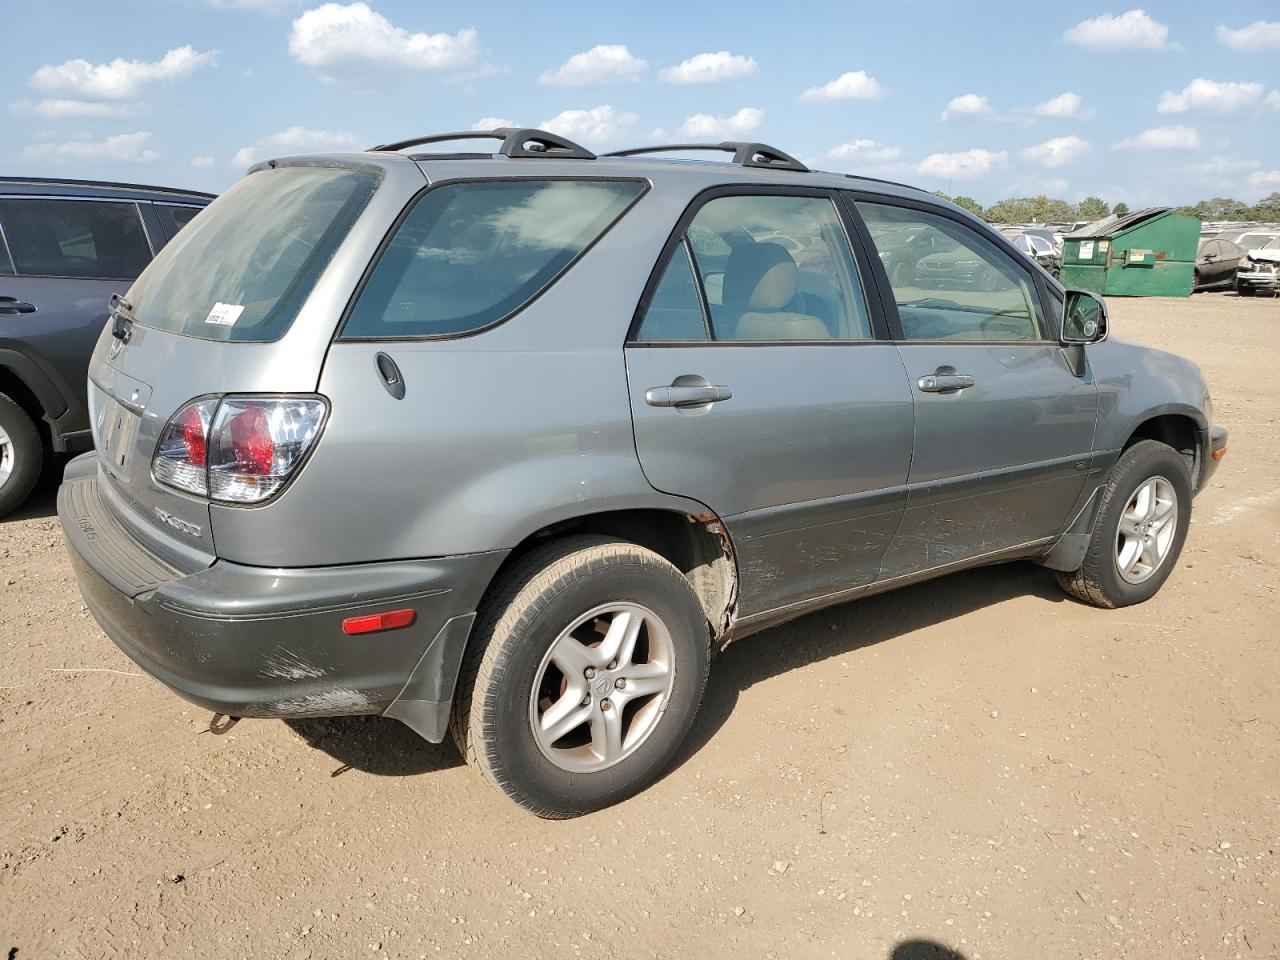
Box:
(0, 177, 214, 516)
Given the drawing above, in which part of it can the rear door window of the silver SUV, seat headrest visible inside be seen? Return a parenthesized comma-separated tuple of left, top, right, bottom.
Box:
(637, 195, 872, 342)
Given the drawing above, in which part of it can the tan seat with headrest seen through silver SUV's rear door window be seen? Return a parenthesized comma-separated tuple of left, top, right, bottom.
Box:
(723, 242, 831, 340)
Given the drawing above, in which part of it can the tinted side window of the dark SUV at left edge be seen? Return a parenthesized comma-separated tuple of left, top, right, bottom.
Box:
(0, 198, 151, 280)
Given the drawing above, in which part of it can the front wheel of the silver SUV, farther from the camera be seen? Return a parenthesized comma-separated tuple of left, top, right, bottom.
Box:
(1057, 440, 1192, 609)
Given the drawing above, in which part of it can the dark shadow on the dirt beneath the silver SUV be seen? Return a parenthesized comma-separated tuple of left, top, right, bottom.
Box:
(294, 563, 1068, 783)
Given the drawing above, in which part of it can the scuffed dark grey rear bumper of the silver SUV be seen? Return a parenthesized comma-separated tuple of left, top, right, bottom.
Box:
(58, 455, 504, 742)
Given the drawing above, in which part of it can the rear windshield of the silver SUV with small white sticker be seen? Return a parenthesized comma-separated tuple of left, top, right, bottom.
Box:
(128, 166, 378, 340)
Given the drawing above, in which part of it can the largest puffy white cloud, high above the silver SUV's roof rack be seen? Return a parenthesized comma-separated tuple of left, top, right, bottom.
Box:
(289, 3, 480, 79)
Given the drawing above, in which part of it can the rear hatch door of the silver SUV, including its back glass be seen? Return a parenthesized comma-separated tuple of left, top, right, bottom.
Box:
(90, 157, 422, 568)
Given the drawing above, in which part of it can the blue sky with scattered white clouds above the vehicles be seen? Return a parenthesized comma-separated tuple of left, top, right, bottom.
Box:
(0, 0, 1280, 207)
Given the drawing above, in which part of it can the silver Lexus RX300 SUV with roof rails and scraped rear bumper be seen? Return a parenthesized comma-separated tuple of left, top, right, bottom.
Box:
(58, 128, 1226, 817)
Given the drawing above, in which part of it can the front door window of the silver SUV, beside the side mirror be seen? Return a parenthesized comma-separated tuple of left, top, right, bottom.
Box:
(858, 201, 1044, 340)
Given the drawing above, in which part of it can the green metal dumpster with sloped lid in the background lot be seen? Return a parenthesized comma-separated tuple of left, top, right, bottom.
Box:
(1061, 207, 1201, 297)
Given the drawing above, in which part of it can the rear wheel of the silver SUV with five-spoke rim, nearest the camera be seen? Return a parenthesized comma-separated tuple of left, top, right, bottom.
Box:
(451, 536, 710, 819)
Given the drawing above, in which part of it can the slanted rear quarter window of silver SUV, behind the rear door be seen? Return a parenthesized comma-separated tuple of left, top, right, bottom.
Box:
(343, 179, 644, 339)
